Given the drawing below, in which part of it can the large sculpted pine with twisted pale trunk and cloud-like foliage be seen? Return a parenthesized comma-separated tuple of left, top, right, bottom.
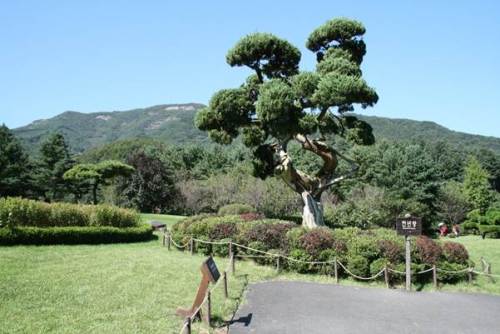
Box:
(195, 19, 378, 228)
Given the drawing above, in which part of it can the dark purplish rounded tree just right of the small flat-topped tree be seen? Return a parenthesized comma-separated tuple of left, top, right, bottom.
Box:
(117, 151, 180, 212)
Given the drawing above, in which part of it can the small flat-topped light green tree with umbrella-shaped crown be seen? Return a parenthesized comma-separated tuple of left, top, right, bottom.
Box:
(63, 160, 134, 204)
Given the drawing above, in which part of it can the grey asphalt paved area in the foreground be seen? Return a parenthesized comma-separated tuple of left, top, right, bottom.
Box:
(229, 282, 500, 334)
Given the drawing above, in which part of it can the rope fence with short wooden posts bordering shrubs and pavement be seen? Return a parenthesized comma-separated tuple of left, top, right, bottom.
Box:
(167, 231, 500, 334)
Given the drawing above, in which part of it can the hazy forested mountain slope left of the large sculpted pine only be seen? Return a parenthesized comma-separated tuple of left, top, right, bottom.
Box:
(14, 103, 207, 152)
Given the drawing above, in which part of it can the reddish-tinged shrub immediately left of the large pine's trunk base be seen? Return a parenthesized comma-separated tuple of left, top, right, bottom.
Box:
(243, 223, 295, 249)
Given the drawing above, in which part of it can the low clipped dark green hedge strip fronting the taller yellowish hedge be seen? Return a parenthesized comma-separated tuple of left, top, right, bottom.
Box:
(0, 224, 156, 245)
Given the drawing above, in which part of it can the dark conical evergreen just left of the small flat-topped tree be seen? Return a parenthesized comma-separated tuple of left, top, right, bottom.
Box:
(37, 133, 74, 201)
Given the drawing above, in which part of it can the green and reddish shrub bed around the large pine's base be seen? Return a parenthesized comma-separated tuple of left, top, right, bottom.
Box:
(171, 215, 470, 282)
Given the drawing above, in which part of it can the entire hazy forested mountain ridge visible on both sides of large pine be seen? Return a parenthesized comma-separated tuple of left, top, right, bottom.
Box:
(10, 103, 500, 154)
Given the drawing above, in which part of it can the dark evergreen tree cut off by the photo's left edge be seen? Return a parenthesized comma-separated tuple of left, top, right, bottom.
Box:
(0, 125, 32, 196)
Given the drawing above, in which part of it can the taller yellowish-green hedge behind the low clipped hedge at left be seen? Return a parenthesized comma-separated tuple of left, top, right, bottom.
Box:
(0, 197, 140, 228)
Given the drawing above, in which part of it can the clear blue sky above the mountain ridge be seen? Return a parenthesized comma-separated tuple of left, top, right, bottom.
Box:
(0, 0, 500, 137)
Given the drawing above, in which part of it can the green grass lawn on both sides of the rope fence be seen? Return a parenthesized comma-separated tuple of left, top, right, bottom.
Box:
(0, 215, 500, 333)
